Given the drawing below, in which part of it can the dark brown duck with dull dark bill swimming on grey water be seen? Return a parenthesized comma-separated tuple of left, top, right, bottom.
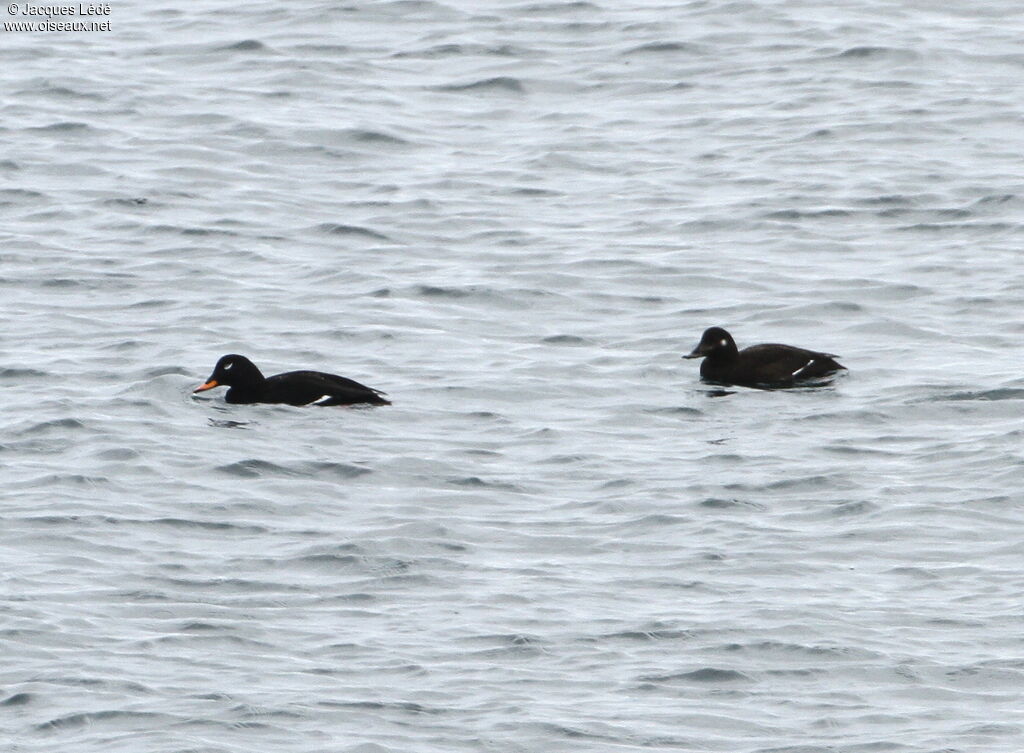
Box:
(683, 327, 846, 388)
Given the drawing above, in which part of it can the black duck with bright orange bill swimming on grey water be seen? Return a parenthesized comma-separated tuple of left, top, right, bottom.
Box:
(194, 353, 391, 406)
